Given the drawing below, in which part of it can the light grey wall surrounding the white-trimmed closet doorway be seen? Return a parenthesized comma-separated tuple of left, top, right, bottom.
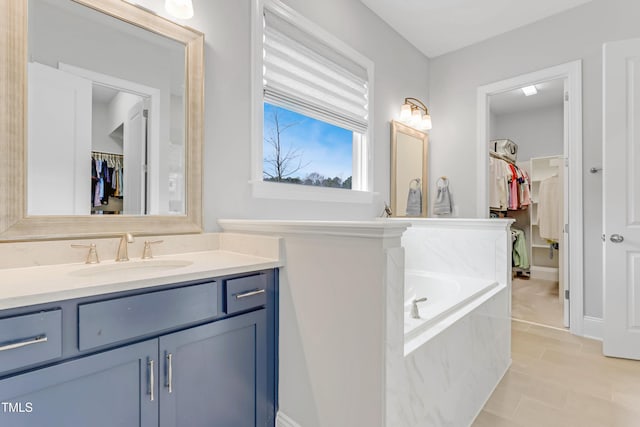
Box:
(429, 0, 640, 317)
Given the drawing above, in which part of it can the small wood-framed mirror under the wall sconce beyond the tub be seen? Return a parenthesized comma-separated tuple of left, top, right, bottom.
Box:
(391, 120, 429, 217)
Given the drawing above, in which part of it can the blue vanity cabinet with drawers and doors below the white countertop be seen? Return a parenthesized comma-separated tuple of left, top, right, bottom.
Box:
(0, 270, 278, 427)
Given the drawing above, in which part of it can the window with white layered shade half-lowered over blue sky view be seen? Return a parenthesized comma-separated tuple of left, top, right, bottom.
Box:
(253, 0, 373, 200)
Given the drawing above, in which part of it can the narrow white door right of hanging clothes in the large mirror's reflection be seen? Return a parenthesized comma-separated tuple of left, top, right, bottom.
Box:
(122, 101, 147, 215)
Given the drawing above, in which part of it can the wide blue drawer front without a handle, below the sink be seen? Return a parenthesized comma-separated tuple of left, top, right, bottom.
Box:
(78, 282, 218, 350)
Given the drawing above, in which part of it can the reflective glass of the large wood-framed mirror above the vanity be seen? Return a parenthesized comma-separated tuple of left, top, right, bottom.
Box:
(27, 0, 186, 215)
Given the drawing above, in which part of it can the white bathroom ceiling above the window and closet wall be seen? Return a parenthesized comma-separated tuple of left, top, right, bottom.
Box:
(361, 0, 592, 58)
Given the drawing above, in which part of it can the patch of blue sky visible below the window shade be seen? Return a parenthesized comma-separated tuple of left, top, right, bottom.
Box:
(263, 102, 353, 186)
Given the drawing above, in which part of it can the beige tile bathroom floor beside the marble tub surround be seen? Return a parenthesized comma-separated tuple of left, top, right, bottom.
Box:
(473, 320, 640, 427)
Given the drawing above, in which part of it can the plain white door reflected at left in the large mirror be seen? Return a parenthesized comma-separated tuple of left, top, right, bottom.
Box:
(27, 62, 92, 215)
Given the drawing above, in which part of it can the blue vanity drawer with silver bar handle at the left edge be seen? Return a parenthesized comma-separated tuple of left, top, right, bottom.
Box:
(0, 310, 62, 371)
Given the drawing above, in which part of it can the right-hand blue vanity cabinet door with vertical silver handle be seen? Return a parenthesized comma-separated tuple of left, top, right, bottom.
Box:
(160, 309, 273, 427)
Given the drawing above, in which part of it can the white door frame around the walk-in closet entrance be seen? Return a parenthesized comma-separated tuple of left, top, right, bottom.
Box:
(476, 60, 584, 335)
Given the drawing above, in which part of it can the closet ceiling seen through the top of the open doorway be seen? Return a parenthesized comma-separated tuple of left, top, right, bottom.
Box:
(489, 79, 564, 116)
